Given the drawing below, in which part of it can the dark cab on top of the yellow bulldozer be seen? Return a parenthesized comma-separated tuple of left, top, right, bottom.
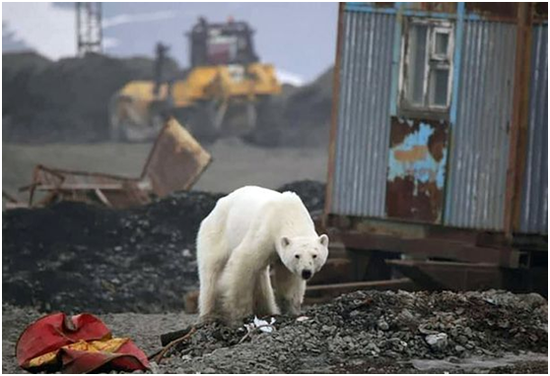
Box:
(188, 17, 259, 67)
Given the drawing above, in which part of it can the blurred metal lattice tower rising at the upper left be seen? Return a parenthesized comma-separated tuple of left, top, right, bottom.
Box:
(75, 3, 103, 56)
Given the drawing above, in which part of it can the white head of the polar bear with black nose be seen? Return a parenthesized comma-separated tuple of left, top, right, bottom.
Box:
(278, 234, 328, 280)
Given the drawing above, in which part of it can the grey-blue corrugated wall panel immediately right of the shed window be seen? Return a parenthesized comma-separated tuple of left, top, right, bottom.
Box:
(444, 21, 516, 230)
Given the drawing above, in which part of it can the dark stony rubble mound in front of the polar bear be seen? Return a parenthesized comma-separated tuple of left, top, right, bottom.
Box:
(163, 291, 548, 373)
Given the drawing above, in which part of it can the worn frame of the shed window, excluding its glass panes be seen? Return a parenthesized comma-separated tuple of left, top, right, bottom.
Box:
(398, 17, 455, 119)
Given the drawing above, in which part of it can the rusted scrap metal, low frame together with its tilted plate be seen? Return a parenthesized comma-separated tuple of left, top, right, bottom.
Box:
(16, 119, 211, 208)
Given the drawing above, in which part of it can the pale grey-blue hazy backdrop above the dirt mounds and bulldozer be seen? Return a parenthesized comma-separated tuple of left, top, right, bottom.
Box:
(2, 3, 338, 81)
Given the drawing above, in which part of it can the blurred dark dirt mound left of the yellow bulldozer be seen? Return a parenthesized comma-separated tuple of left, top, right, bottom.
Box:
(2, 53, 179, 142)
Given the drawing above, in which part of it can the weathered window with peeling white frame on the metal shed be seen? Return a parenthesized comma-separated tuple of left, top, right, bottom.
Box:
(399, 19, 454, 114)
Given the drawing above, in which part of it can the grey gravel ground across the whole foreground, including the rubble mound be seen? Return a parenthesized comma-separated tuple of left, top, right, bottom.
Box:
(3, 291, 548, 373)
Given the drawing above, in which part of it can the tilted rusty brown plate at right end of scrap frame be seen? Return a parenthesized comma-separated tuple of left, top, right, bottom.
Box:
(142, 118, 212, 197)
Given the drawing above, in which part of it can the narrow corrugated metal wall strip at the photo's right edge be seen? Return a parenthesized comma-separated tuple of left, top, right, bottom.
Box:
(520, 25, 548, 234)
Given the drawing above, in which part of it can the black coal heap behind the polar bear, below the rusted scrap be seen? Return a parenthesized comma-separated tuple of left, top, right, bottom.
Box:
(2, 181, 324, 313)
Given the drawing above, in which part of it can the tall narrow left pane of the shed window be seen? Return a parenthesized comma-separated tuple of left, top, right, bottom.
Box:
(408, 25, 428, 105)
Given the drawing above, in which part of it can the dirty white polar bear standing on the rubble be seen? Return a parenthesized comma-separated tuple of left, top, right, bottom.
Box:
(197, 186, 329, 324)
